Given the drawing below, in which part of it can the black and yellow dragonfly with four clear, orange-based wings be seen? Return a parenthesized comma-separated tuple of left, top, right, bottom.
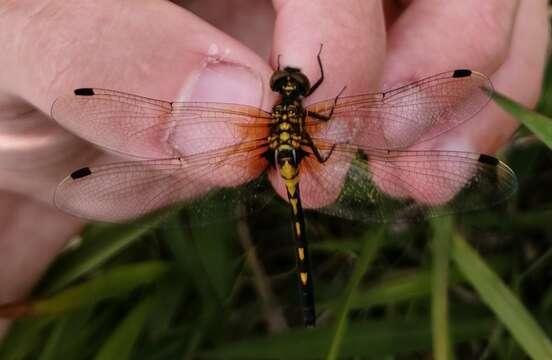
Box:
(51, 48, 517, 327)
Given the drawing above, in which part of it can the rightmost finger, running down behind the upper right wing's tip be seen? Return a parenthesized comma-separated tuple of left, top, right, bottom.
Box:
(380, 0, 549, 202)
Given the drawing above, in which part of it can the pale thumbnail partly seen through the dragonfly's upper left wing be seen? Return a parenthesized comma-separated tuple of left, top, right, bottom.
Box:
(170, 61, 270, 174)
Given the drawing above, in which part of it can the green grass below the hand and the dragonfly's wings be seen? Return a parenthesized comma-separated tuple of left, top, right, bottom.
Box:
(0, 28, 552, 360)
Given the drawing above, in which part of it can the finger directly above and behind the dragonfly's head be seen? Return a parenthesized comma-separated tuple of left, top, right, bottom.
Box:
(270, 0, 385, 203)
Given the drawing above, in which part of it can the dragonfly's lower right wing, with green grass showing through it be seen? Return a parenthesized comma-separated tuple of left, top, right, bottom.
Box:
(296, 148, 517, 222)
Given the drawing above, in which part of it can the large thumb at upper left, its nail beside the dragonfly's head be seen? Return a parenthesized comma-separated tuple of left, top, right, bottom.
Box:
(0, 0, 270, 159)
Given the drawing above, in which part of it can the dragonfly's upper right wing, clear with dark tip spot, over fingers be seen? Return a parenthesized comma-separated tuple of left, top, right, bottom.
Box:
(307, 69, 493, 149)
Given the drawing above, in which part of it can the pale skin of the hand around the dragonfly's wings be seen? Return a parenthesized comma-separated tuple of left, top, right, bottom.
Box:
(0, 0, 548, 334)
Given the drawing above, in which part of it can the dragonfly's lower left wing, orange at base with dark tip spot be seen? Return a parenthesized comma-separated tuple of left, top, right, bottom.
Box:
(54, 144, 268, 223)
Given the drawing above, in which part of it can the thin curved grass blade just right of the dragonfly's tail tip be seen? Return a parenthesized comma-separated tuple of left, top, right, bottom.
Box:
(326, 230, 384, 360)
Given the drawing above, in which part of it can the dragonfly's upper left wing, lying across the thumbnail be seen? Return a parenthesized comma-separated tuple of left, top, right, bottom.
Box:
(51, 88, 270, 159)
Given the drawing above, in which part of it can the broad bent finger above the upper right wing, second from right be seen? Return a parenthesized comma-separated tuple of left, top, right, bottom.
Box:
(378, 0, 517, 150)
